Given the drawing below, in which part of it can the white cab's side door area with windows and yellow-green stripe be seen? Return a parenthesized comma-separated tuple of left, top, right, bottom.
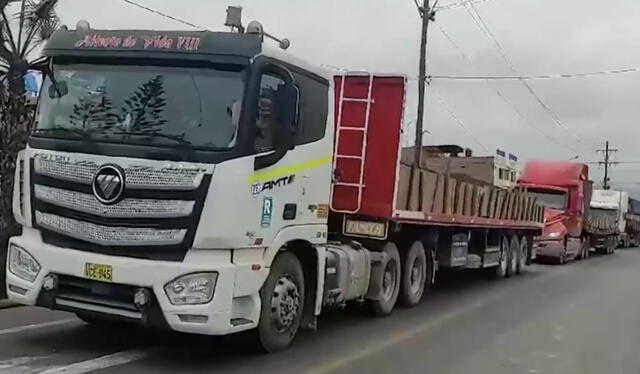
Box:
(249, 61, 332, 247)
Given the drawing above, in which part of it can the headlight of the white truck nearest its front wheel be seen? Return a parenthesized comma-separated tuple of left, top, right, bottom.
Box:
(164, 273, 218, 305)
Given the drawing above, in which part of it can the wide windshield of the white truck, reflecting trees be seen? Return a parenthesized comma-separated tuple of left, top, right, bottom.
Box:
(34, 64, 244, 150)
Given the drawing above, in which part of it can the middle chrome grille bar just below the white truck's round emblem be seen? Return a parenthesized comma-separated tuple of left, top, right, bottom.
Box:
(34, 185, 195, 218)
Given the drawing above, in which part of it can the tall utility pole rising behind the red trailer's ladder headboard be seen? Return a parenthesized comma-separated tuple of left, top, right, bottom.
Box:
(415, 0, 437, 166)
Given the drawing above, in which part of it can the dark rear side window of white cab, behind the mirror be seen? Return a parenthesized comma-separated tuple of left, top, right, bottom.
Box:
(294, 73, 329, 145)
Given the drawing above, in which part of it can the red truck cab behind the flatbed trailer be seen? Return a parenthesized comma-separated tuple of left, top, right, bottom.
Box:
(518, 160, 591, 263)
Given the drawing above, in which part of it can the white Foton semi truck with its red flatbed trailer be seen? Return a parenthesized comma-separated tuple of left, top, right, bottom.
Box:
(7, 17, 543, 351)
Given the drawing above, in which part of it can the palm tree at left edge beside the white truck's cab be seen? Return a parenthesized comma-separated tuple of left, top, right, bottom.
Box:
(0, 0, 60, 298)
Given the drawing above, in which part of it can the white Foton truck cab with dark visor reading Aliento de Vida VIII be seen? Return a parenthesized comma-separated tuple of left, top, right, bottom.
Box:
(7, 24, 334, 346)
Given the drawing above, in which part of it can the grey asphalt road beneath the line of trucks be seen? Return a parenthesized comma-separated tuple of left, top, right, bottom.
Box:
(0, 249, 640, 374)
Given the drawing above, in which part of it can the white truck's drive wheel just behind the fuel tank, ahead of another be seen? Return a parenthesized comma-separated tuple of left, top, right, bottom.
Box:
(370, 242, 402, 316)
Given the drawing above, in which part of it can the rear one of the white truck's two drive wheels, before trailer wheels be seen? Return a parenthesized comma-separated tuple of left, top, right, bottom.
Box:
(399, 240, 430, 307)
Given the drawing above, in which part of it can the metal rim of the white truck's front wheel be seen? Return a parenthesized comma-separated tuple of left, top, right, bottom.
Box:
(271, 275, 300, 332)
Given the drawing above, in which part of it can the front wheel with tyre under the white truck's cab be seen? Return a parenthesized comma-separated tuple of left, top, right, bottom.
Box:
(255, 252, 304, 353)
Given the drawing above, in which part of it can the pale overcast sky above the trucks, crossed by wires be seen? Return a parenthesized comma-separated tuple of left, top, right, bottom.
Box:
(52, 0, 640, 197)
